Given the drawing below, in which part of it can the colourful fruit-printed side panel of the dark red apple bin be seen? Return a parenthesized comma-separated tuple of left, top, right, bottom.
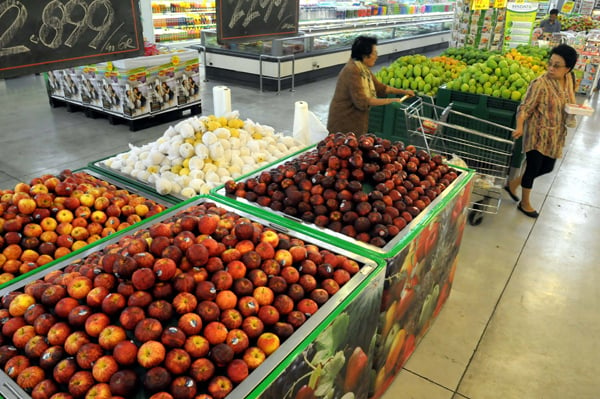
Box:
(369, 183, 472, 398)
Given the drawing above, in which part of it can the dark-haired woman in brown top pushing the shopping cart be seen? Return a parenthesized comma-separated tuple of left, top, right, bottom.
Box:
(327, 36, 415, 135)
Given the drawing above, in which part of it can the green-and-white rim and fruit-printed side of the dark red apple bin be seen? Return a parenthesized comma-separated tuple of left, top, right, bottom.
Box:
(211, 142, 474, 398)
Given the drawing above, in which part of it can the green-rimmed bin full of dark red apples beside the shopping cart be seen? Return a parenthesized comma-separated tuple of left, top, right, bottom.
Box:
(213, 134, 473, 397)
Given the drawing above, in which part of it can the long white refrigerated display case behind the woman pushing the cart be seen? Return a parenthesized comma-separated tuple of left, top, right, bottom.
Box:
(190, 12, 453, 90)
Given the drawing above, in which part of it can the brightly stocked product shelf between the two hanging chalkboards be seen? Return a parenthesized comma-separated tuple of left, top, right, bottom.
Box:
(152, 0, 215, 44)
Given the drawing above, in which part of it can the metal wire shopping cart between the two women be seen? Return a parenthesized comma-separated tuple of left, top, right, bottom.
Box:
(399, 97, 514, 226)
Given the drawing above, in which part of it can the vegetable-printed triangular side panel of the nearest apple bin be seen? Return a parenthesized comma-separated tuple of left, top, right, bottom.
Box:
(253, 270, 384, 399)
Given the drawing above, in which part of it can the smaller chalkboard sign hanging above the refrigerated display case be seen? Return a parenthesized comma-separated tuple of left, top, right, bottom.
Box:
(216, 0, 300, 43)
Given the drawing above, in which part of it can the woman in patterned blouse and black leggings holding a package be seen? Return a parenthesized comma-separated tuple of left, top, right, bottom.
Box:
(504, 44, 577, 218)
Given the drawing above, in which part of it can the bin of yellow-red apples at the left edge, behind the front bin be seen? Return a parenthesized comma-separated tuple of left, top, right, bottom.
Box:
(0, 169, 170, 288)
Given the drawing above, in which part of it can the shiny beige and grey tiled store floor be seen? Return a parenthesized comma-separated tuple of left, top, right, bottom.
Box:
(0, 66, 600, 399)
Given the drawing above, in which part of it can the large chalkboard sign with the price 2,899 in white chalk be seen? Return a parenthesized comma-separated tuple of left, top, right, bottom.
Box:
(0, 0, 144, 77)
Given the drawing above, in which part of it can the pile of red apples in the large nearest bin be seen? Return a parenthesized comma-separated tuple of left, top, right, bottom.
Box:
(0, 202, 360, 399)
